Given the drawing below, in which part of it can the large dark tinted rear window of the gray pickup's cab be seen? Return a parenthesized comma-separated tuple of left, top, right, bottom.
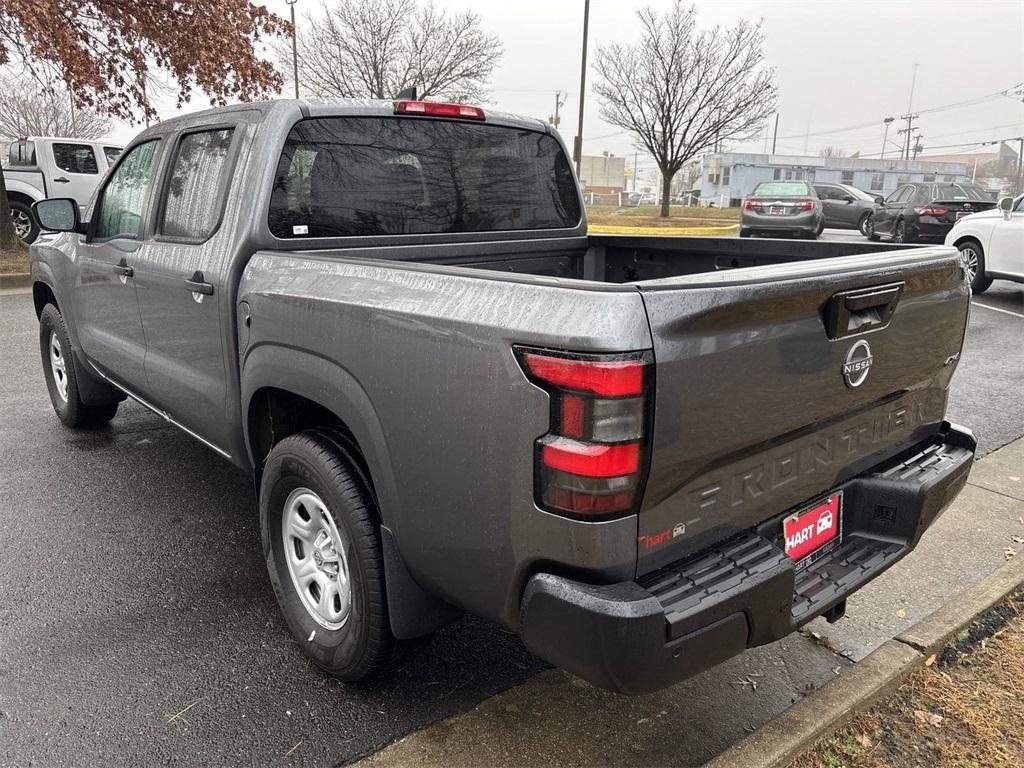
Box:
(269, 118, 581, 238)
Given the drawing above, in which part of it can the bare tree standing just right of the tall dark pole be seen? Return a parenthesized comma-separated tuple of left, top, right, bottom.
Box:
(594, 0, 776, 216)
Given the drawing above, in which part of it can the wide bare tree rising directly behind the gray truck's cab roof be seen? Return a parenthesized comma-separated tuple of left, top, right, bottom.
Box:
(279, 0, 502, 100)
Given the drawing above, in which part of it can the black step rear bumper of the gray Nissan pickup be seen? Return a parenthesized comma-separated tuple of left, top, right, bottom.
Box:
(521, 424, 975, 693)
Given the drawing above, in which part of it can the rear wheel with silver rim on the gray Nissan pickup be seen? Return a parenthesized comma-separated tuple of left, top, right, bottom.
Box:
(259, 430, 407, 682)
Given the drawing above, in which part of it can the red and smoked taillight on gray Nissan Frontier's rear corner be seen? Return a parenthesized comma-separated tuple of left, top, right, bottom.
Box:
(515, 346, 653, 519)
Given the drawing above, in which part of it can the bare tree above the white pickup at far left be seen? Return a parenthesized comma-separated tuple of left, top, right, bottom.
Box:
(0, 72, 111, 139)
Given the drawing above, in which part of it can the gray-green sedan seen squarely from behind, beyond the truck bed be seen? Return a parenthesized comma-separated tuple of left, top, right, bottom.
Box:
(739, 181, 825, 240)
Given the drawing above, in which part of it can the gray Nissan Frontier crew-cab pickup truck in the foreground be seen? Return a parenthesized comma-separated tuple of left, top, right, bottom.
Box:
(32, 100, 975, 692)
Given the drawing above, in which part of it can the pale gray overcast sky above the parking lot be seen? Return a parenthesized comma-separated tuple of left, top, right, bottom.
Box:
(117, 0, 1024, 174)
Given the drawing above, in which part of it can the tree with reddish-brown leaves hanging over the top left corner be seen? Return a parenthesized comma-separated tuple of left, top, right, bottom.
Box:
(0, 0, 291, 248)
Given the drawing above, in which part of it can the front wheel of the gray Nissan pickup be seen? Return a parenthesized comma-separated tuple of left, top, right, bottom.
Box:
(39, 304, 120, 429)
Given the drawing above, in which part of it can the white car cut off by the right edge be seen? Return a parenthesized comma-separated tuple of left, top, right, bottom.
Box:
(946, 195, 1024, 293)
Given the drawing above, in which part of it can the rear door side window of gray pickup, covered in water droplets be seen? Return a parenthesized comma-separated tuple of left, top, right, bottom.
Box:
(160, 128, 234, 241)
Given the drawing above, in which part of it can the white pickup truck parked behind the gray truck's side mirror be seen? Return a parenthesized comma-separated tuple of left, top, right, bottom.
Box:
(3, 137, 121, 243)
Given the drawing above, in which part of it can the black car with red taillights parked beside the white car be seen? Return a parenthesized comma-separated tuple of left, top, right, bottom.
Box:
(864, 181, 995, 243)
